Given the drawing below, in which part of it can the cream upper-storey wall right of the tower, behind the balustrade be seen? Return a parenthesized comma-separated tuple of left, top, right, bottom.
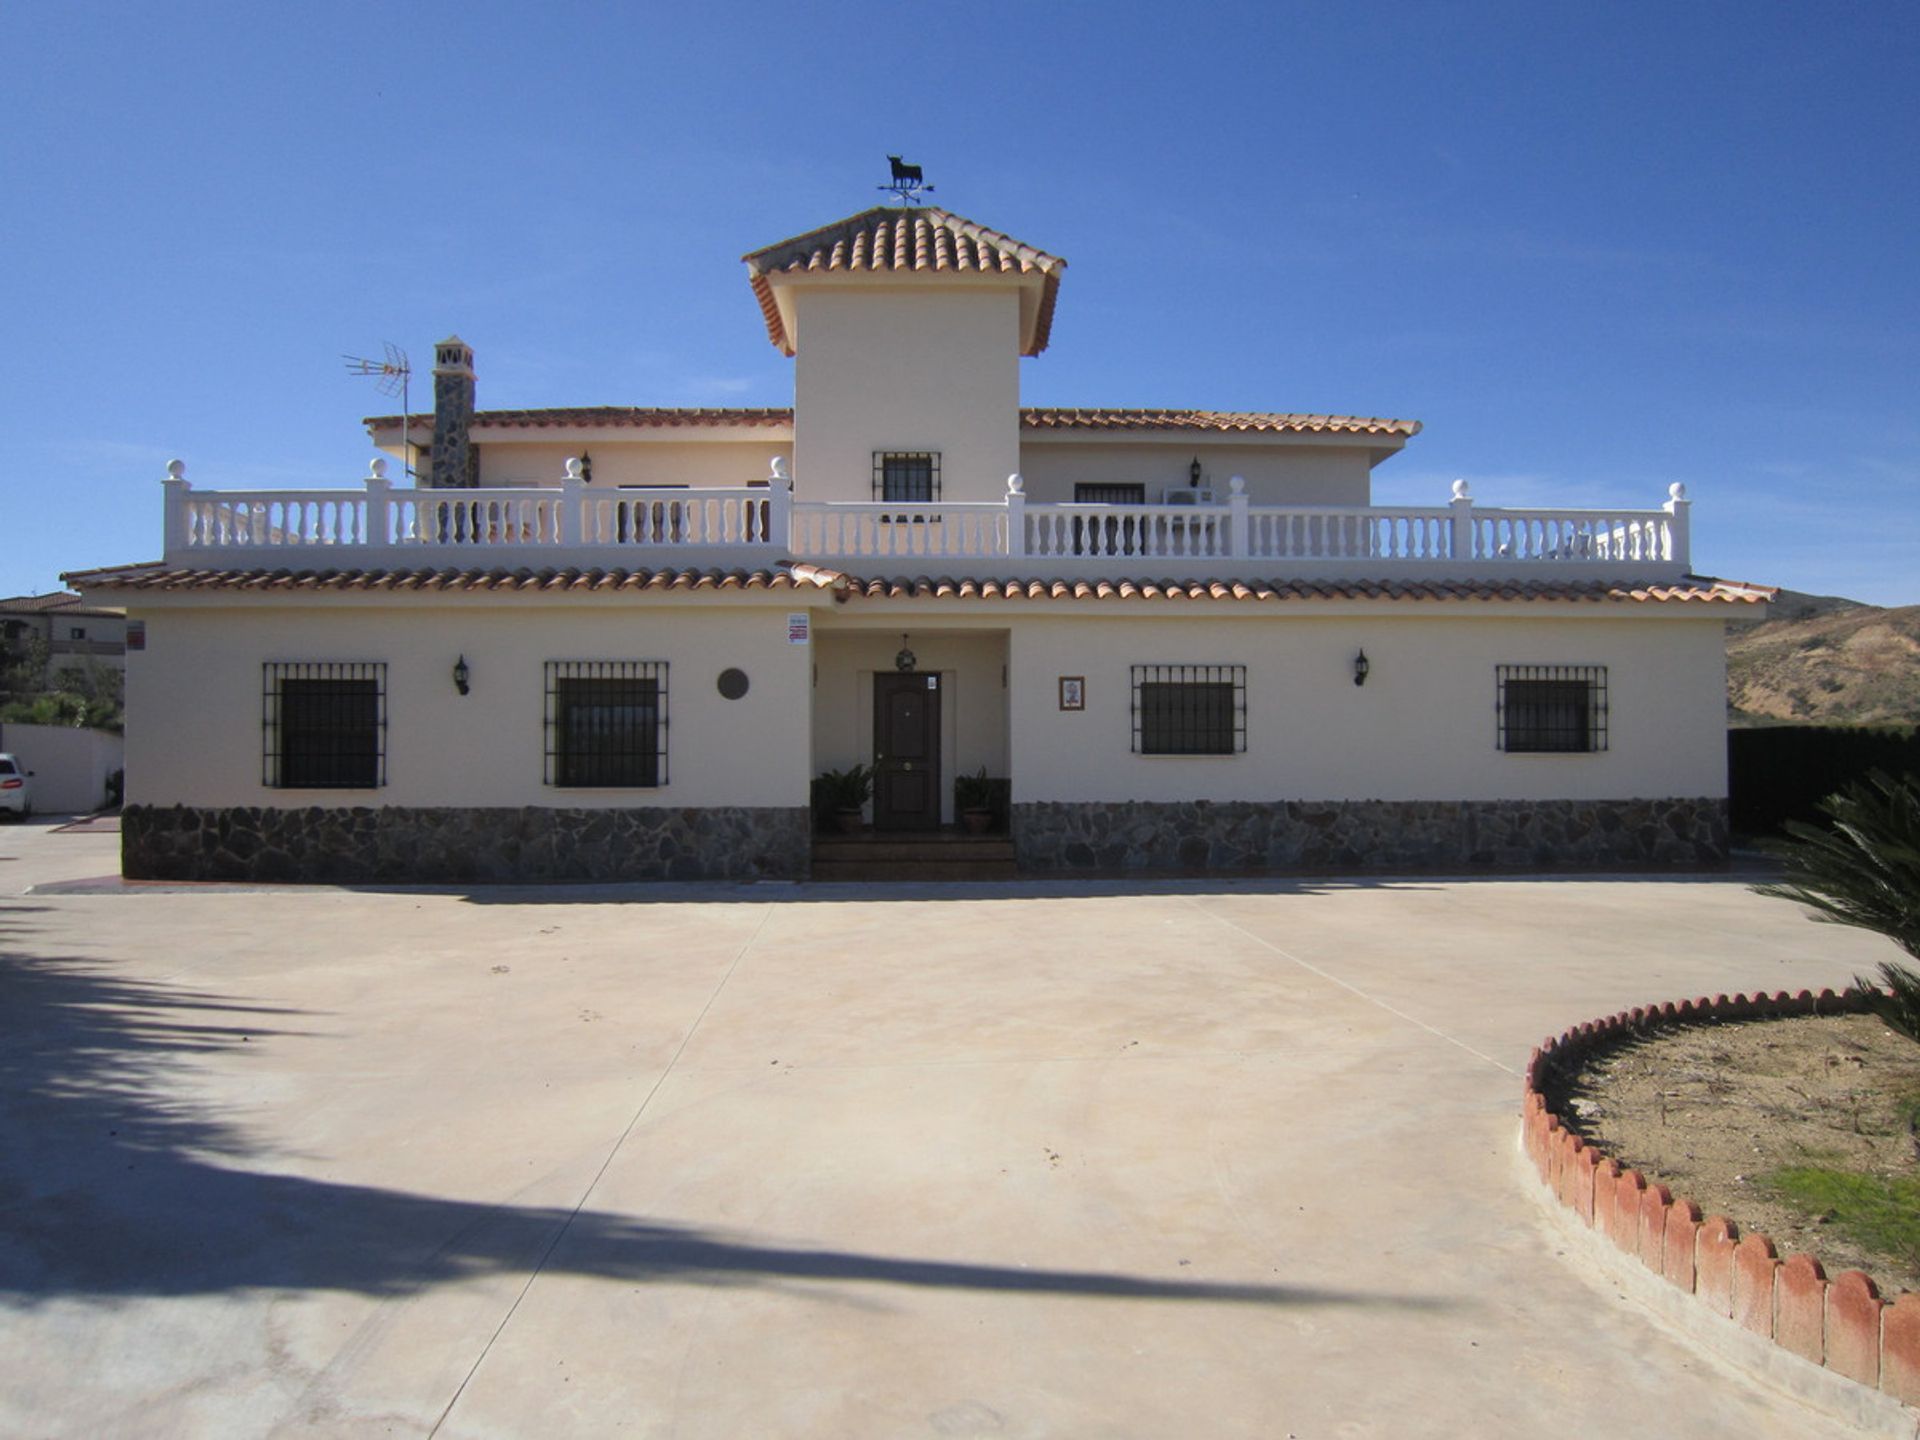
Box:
(1020, 443, 1382, 505)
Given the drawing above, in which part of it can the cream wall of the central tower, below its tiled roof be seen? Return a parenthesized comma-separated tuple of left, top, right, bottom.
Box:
(791, 276, 1020, 501)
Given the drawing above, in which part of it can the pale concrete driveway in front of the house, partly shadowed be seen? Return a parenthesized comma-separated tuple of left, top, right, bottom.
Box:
(0, 822, 1893, 1440)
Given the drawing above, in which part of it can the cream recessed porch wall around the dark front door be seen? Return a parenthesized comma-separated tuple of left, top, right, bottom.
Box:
(812, 628, 1008, 822)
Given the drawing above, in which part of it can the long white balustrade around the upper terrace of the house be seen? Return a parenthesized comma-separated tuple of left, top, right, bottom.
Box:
(165, 461, 1690, 578)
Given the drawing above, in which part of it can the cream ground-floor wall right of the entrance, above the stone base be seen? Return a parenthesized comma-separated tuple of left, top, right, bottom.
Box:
(1010, 607, 1726, 803)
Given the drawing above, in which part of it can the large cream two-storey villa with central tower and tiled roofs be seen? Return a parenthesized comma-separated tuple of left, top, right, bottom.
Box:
(69, 207, 1770, 879)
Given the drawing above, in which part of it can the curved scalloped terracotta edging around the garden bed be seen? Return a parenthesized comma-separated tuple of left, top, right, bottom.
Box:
(1521, 989, 1920, 1428)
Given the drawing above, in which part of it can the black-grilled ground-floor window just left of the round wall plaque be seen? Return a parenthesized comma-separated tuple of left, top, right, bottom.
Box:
(545, 660, 666, 789)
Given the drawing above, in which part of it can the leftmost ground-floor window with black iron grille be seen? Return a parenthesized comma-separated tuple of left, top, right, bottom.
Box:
(261, 660, 386, 789)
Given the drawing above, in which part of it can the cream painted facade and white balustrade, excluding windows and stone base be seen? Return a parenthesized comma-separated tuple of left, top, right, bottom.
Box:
(81, 201, 1749, 879)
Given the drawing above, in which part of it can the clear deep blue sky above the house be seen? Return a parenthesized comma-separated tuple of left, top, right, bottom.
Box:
(0, 0, 1920, 605)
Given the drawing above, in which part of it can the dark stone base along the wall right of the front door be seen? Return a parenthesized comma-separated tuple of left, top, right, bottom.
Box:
(1010, 799, 1728, 874)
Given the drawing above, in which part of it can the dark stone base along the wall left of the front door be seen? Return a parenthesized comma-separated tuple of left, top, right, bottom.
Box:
(121, 804, 812, 885)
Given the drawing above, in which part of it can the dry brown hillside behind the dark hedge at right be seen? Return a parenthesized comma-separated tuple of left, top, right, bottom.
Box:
(1726, 589, 1920, 726)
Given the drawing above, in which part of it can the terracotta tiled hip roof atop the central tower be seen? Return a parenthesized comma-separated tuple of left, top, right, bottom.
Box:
(741, 205, 1068, 355)
